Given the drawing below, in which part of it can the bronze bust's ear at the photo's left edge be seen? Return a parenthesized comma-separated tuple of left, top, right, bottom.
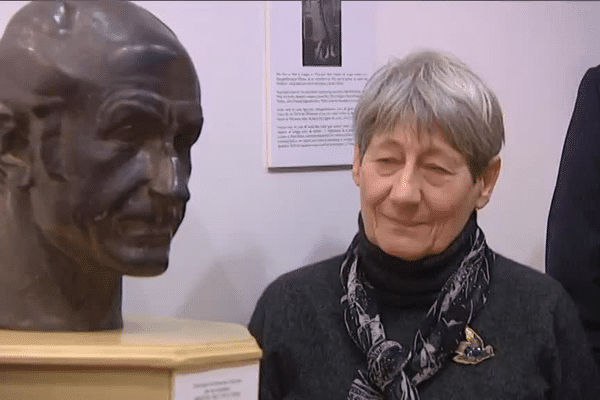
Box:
(0, 102, 31, 188)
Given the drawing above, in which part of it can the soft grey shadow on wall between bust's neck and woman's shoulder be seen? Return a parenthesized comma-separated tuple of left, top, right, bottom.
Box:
(176, 242, 268, 325)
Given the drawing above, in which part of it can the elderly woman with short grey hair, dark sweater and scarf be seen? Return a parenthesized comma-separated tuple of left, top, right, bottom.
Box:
(250, 51, 600, 400)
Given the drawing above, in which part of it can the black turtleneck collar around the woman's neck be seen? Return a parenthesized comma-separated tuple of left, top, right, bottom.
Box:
(358, 212, 477, 307)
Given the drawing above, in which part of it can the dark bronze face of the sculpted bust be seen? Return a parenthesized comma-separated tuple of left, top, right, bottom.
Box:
(29, 49, 202, 276)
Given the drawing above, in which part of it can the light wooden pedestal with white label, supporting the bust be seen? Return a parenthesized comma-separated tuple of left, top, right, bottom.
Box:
(0, 317, 261, 400)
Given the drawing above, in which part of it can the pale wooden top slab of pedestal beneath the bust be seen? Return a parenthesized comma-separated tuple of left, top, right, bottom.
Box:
(0, 316, 261, 369)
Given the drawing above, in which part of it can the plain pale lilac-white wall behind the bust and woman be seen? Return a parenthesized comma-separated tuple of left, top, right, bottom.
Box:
(0, 1, 600, 324)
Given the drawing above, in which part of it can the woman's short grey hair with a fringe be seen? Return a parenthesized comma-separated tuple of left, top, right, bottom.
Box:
(354, 50, 504, 179)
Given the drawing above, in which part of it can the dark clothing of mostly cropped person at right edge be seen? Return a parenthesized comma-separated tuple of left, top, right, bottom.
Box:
(546, 66, 600, 365)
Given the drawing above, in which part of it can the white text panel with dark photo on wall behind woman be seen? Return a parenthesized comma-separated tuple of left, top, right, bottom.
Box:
(265, 0, 375, 168)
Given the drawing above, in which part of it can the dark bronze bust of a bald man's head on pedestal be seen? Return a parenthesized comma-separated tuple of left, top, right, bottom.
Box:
(0, 1, 203, 331)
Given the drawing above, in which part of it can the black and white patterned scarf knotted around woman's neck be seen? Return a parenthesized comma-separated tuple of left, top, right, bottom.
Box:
(340, 220, 494, 400)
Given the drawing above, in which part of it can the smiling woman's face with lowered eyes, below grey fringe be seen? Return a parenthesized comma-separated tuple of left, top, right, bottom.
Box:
(352, 124, 500, 260)
